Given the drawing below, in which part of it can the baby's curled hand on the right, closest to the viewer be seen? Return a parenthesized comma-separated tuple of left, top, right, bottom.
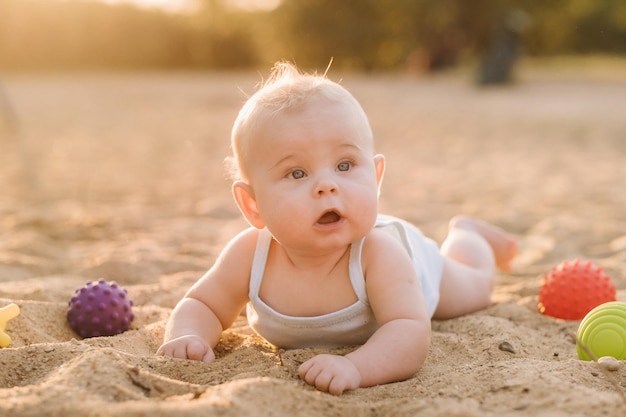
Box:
(298, 354, 361, 395)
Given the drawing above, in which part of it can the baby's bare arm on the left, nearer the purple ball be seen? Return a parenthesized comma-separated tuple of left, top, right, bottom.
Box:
(157, 229, 257, 362)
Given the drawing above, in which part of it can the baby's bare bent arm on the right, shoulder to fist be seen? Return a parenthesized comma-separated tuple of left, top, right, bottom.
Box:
(299, 230, 430, 395)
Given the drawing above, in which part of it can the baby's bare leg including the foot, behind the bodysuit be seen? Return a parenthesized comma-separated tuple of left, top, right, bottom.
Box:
(434, 216, 517, 319)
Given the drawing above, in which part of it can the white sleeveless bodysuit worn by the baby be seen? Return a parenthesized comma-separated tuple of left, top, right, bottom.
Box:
(247, 215, 443, 348)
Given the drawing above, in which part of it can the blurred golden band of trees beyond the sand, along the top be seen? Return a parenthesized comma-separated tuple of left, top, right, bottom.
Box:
(0, 0, 626, 73)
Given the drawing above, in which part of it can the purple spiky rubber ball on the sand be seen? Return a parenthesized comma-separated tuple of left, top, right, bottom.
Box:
(67, 279, 135, 337)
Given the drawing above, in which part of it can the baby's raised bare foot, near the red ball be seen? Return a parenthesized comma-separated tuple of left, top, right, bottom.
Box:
(450, 216, 517, 272)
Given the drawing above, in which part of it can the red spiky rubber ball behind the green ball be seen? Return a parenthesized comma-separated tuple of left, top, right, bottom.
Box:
(538, 259, 616, 320)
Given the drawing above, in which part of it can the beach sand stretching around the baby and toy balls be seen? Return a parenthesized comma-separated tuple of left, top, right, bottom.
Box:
(0, 62, 626, 417)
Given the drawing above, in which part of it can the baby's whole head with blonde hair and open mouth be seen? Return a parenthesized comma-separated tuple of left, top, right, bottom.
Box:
(232, 63, 384, 250)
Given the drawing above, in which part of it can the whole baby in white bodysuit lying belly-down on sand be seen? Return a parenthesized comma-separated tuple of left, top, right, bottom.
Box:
(158, 63, 517, 395)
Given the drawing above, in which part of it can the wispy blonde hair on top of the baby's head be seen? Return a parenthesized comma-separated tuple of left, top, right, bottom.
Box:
(226, 61, 369, 180)
